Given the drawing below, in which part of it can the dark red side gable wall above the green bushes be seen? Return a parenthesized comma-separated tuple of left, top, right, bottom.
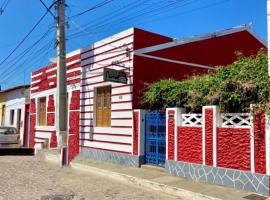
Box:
(133, 31, 266, 109)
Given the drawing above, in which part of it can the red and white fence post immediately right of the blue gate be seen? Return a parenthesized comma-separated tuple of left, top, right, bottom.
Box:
(166, 108, 185, 161)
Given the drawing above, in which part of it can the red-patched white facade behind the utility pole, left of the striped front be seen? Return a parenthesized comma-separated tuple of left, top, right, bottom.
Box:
(29, 50, 81, 160)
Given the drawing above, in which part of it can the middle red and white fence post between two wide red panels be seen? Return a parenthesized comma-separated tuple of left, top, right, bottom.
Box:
(202, 106, 221, 167)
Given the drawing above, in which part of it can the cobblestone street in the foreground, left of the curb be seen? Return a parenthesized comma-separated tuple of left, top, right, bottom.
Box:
(0, 156, 179, 200)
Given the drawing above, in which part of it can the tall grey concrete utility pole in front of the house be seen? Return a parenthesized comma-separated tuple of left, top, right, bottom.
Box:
(55, 0, 68, 166)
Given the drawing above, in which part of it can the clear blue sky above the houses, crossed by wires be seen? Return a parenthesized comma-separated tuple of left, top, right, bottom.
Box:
(0, 0, 267, 88)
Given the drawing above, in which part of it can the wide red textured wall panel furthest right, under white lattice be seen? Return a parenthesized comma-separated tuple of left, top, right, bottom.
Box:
(217, 128, 250, 170)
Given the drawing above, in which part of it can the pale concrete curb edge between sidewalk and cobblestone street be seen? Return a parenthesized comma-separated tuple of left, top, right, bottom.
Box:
(45, 154, 221, 200)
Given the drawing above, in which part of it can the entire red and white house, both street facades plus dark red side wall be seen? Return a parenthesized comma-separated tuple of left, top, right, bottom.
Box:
(30, 27, 266, 166)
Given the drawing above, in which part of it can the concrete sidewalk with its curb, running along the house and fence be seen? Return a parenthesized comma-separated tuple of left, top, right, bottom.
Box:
(45, 151, 269, 200)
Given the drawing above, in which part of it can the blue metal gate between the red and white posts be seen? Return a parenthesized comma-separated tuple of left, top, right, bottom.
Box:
(145, 111, 166, 167)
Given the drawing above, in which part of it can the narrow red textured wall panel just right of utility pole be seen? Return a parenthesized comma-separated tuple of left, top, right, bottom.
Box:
(68, 111, 80, 163)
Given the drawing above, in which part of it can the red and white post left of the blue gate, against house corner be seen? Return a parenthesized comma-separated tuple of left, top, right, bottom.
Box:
(132, 110, 145, 156)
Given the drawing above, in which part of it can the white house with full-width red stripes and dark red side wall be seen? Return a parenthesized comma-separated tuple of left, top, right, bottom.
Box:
(80, 26, 266, 166)
